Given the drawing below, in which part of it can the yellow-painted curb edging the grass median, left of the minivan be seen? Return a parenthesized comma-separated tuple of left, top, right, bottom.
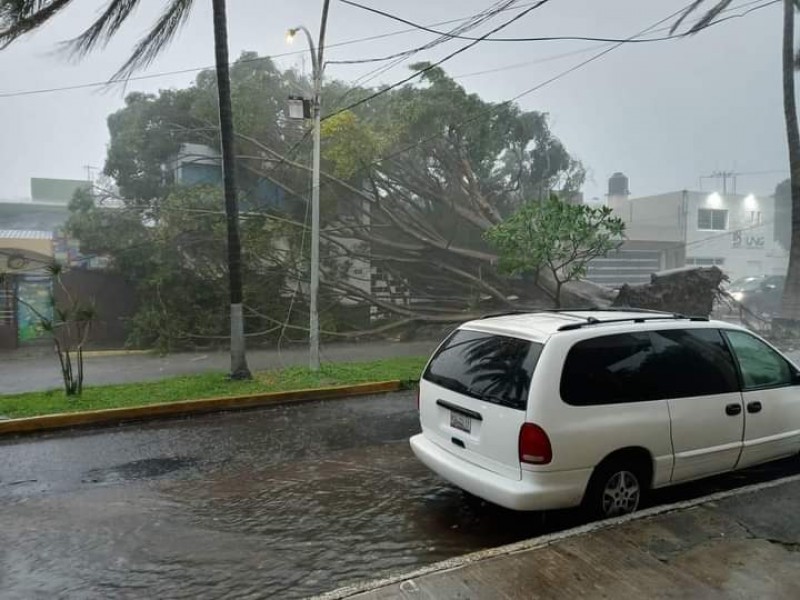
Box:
(0, 380, 403, 436)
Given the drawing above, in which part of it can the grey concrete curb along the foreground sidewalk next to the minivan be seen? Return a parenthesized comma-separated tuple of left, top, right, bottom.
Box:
(309, 475, 800, 600)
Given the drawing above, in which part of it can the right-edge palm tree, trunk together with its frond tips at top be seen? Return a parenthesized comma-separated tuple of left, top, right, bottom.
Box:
(672, 0, 800, 322)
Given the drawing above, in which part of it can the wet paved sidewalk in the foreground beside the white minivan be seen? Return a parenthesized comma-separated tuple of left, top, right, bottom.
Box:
(322, 476, 800, 600)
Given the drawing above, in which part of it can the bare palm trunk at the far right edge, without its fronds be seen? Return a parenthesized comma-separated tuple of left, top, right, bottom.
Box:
(782, 0, 800, 321)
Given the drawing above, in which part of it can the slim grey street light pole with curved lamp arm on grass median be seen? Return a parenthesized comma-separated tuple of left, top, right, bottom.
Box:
(289, 0, 330, 371)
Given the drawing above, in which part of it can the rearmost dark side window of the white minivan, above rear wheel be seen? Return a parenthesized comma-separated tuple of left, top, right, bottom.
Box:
(561, 332, 655, 406)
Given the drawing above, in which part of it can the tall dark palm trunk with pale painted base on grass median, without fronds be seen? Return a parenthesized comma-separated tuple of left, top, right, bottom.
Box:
(212, 0, 252, 379)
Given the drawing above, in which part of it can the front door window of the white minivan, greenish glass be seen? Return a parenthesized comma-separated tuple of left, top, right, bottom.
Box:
(725, 331, 794, 390)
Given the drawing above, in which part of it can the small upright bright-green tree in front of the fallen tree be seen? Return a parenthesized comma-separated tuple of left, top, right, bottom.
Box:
(485, 196, 625, 307)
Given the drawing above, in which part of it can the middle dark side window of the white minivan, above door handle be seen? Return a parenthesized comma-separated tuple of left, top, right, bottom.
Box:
(648, 329, 739, 399)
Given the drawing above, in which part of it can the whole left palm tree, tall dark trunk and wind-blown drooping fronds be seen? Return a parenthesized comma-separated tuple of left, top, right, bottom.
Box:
(0, 0, 251, 379)
